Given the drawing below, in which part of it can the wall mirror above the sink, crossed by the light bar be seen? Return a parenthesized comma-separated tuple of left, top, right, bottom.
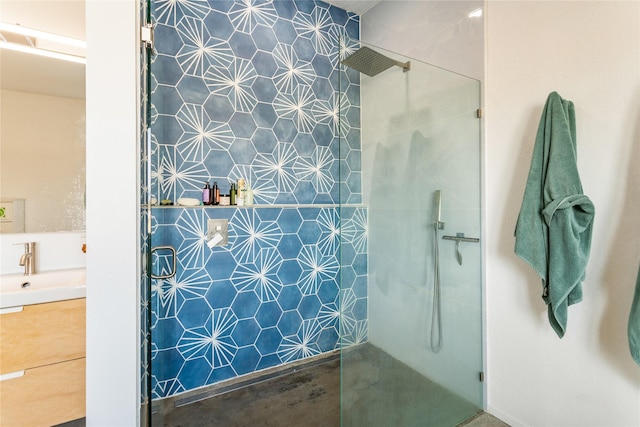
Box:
(0, 0, 85, 233)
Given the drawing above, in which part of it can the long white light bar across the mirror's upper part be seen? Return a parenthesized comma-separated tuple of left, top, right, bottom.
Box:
(0, 22, 87, 64)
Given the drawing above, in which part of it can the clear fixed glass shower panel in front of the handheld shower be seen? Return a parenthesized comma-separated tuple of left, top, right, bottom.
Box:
(340, 42, 482, 426)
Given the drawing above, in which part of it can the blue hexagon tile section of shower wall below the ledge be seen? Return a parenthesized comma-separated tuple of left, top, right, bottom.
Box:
(151, 207, 367, 398)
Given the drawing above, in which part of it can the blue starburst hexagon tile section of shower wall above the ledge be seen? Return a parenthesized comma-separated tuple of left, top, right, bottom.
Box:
(151, 0, 362, 205)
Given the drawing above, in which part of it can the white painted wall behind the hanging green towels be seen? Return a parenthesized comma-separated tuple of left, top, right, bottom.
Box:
(485, 1, 640, 427)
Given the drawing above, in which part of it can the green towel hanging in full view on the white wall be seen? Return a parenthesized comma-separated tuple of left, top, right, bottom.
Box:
(515, 92, 594, 338)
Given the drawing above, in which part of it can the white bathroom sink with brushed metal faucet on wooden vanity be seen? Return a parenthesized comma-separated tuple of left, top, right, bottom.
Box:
(0, 268, 87, 309)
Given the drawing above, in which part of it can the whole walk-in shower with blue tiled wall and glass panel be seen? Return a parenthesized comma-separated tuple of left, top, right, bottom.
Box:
(141, 0, 482, 427)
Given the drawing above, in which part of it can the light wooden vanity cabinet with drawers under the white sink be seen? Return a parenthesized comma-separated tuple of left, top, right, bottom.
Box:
(0, 298, 86, 427)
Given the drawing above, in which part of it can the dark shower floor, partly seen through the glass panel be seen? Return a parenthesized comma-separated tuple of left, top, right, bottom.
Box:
(56, 345, 508, 427)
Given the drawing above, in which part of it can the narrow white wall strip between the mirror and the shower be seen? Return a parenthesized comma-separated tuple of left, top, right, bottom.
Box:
(86, 0, 140, 427)
